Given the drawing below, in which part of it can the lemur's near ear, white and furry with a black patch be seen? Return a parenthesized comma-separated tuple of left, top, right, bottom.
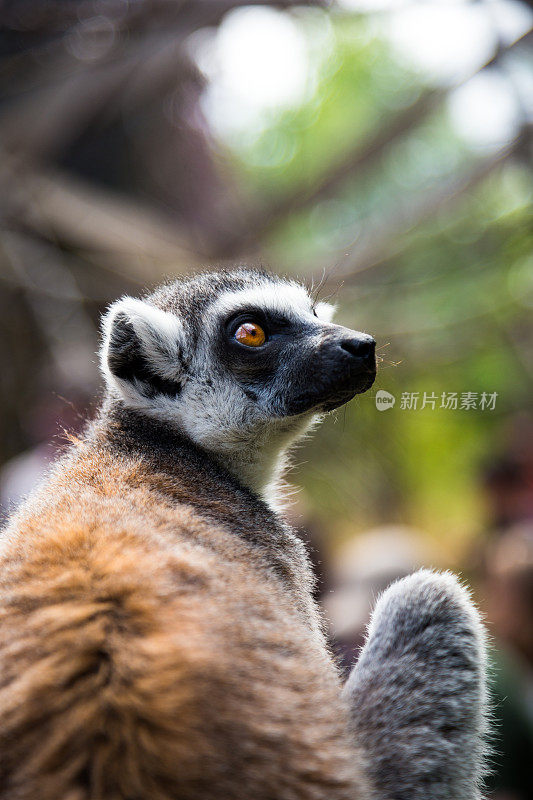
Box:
(100, 297, 184, 404)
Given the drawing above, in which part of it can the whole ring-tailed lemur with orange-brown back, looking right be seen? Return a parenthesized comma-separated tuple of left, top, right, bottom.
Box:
(0, 268, 485, 800)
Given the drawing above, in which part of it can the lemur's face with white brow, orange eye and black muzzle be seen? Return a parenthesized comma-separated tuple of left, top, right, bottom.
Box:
(210, 282, 376, 418)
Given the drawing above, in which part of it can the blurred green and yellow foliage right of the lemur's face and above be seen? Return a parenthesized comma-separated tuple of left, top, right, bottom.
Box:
(214, 10, 533, 558)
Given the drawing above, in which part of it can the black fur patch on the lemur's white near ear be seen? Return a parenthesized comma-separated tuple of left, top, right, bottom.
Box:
(107, 312, 182, 397)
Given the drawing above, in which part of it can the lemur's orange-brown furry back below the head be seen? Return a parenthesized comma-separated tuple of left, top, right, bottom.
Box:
(0, 412, 366, 800)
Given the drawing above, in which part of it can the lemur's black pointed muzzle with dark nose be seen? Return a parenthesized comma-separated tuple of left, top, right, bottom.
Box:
(284, 325, 376, 414)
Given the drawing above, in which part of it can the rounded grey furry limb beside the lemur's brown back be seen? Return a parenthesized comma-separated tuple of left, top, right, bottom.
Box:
(344, 570, 487, 800)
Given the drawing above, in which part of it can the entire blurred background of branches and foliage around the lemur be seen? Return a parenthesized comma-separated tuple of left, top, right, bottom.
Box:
(0, 0, 533, 800)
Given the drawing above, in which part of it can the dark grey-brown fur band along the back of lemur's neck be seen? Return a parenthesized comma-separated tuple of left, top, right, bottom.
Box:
(85, 403, 319, 631)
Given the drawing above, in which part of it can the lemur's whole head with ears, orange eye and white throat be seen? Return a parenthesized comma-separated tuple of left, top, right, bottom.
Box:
(101, 269, 376, 500)
